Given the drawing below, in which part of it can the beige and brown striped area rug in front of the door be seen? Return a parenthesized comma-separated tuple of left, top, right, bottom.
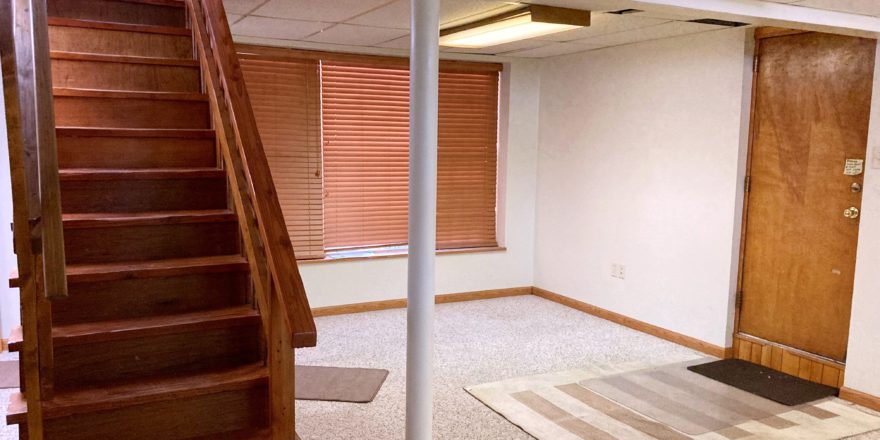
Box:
(466, 358, 880, 440)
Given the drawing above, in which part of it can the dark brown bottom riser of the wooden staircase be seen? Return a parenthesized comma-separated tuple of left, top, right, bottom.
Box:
(20, 385, 269, 440)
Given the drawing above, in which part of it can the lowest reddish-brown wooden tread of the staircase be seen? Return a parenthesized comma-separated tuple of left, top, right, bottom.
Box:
(6, 362, 268, 424)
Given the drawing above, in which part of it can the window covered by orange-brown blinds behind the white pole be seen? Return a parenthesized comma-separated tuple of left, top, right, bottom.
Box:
(239, 46, 501, 259)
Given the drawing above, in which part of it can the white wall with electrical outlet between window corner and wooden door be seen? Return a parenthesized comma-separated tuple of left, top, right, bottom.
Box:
(535, 29, 751, 347)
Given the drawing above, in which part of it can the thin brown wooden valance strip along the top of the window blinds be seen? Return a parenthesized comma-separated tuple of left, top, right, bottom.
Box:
(235, 43, 504, 72)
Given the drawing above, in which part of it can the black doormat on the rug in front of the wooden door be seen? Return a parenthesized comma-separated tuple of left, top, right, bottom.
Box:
(688, 359, 839, 406)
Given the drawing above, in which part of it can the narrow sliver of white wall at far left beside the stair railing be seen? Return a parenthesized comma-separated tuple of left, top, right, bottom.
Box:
(0, 76, 20, 339)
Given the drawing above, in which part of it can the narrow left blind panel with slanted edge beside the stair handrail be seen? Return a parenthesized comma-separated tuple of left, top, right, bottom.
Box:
(241, 58, 324, 259)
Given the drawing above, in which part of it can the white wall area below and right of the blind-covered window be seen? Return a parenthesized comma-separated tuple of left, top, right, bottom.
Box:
(300, 60, 540, 307)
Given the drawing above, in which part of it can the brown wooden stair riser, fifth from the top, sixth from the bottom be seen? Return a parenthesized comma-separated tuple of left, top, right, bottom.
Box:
(58, 136, 217, 169)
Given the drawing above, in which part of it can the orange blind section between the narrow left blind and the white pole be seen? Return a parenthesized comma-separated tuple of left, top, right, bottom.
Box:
(321, 62, 409, 249)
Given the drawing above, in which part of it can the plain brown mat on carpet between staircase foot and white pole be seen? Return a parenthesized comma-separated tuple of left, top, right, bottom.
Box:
(295, 365, 388, 403)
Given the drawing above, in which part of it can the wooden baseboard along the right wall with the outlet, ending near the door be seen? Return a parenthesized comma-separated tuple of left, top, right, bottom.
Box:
(532, 287, 733, 359)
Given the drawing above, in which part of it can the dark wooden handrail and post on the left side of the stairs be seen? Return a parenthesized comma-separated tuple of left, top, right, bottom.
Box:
(0, 0, 67, 439)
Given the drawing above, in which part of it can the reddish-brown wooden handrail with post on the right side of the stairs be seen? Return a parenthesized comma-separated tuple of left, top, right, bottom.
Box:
(186, 0, 317, 434)
